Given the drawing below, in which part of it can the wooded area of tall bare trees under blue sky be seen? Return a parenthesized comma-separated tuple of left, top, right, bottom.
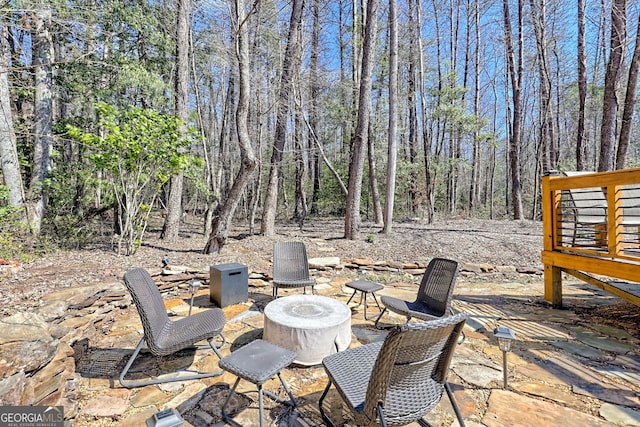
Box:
(0, 0, 640, 255)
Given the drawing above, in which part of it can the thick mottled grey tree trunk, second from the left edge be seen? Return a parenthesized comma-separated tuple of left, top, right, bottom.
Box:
(28, 10, 53, 234)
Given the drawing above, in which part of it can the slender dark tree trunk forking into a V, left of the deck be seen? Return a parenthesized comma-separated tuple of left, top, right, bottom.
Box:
(502, 0, 523, 220)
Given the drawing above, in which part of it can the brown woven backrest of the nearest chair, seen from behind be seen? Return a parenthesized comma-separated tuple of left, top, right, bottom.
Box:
(363, 312, 467, 424)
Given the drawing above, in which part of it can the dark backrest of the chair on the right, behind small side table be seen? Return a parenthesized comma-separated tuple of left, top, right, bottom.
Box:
(416, 258, 458, 316)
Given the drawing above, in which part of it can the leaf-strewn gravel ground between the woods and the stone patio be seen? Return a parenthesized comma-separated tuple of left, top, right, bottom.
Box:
(0, 217, 542, 316)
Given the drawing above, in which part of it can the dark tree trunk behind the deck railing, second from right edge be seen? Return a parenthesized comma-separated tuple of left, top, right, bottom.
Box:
(598, 0, 627, 172)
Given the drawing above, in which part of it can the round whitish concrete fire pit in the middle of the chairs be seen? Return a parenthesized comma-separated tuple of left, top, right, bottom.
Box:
(263, 295, 351, 366)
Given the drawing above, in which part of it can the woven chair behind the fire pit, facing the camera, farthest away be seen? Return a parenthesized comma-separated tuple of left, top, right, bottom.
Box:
(273, 242, 316, 298)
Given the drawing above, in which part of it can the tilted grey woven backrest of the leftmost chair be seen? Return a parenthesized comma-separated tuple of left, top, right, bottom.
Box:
(124, 267, 169, 352)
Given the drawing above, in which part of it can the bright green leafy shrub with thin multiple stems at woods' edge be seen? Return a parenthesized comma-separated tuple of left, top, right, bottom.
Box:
(66, 103, 191, 255)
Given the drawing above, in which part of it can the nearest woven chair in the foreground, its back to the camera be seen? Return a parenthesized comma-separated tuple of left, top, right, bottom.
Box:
(319, 313, 467, 427)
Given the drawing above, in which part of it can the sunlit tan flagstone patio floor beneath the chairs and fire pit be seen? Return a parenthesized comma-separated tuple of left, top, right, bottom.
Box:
(70, 277, 640, 427)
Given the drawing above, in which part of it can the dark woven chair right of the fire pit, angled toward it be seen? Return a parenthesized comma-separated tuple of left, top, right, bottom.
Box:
(375, 258, 458, 327)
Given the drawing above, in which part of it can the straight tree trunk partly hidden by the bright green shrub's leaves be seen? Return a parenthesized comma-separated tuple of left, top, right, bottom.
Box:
(160, 0, 191, 241)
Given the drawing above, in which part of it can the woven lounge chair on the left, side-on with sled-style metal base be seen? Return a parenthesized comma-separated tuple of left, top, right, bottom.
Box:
(120, 268, 226, 388)
